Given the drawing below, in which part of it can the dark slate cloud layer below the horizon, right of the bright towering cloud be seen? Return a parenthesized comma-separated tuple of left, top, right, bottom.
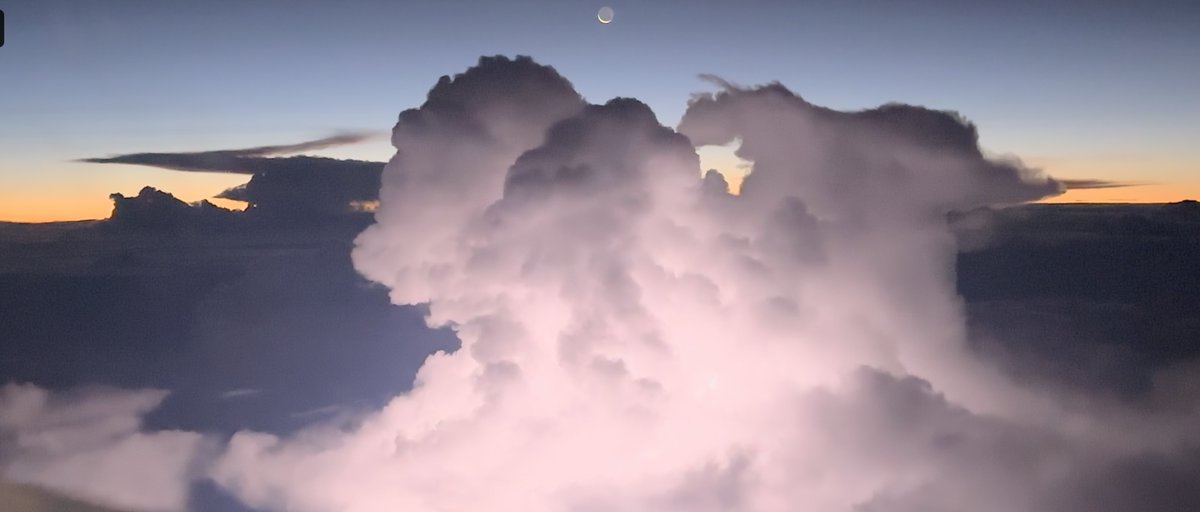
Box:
(958, 201, 1200, 399)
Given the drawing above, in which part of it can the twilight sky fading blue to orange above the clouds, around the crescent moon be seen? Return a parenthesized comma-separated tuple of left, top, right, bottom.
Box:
(0, 0, 1200, 222)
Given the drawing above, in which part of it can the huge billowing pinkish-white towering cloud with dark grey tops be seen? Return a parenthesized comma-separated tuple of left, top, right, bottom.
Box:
(212, 58, 1200, 512)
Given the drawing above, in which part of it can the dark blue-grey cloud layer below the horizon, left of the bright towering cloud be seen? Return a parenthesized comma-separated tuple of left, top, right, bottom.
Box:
(0, 196, 456, 512)
